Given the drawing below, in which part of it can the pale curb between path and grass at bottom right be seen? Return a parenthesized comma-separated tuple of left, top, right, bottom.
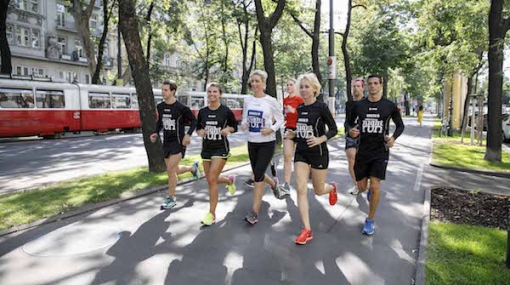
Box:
(414, 187, 430, 285)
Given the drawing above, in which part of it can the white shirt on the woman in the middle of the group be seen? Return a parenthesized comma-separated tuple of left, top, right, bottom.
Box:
(242, 95, 284, 143)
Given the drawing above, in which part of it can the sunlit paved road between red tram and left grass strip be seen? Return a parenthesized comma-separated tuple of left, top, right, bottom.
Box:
(0, 116, 344, 194)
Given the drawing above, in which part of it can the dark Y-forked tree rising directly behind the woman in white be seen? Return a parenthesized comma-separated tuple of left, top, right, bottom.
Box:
(255, 0, 286, 98)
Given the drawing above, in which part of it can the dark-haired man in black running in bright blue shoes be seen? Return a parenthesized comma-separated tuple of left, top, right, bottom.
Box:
(348, 75, 404, 235)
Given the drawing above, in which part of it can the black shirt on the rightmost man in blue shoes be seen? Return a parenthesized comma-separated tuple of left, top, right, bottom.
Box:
(347, 98, 404, 158)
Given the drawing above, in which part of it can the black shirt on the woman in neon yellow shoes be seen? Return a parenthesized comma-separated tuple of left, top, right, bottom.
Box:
(197, 105, 237, 149)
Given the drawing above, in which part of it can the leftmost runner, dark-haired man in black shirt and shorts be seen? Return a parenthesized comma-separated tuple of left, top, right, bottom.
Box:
(150, 81, 200, 210)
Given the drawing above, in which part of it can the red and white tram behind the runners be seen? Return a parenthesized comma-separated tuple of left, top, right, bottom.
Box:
(0, 79, 246, 138)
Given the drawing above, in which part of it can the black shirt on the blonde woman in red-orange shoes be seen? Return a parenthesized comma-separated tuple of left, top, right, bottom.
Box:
(294, 101, 338, 153)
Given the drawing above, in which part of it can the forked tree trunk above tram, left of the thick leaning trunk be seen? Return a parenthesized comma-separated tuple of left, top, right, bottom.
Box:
(72, 0, 97, 79)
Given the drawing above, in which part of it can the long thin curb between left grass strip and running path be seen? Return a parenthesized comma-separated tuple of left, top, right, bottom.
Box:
(0, 162, 250, 237)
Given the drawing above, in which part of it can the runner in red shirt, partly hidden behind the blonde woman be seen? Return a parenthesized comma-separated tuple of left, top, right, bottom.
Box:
(280, 79, 304, 195)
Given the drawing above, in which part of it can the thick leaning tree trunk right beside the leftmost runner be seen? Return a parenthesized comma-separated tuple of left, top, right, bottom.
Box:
(119, 0, 166, 172)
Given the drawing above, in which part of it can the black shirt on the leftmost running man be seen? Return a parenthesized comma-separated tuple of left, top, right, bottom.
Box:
(156, 101, 197, 146)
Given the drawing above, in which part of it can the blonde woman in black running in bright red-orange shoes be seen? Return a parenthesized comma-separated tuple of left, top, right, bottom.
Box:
(285, 73, 338, 244)
